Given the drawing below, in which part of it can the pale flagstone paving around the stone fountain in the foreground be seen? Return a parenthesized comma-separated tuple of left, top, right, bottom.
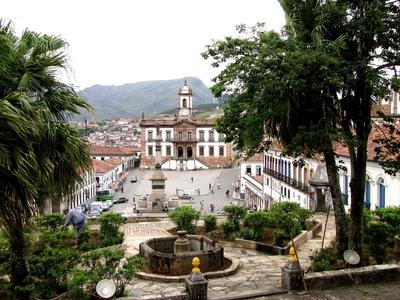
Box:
(124, 214, 335, 299)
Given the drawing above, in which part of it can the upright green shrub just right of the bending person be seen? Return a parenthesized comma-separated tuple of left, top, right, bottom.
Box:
(99, 212, 124, 247)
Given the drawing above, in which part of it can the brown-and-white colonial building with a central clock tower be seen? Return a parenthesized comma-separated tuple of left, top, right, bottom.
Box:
(140, 82, 233, 170)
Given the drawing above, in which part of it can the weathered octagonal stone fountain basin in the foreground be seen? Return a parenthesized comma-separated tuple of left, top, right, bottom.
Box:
(139, 235, 224, 276)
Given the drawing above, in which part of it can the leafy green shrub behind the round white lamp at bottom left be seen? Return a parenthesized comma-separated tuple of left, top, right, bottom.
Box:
(69, 249, 144, 299)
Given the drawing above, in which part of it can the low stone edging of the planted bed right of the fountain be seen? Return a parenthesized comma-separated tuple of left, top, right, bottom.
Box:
(233, 222, 322, 255)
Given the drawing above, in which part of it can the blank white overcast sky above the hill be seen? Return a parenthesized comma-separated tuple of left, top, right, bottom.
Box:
(0, 0, 284, 89)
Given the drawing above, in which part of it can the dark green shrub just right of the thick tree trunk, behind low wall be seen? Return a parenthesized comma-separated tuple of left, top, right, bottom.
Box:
(365, 221, 390, 264)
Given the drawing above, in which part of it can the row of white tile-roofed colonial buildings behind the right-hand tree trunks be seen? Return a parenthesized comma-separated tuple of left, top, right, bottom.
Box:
(241, 92, 400, 211)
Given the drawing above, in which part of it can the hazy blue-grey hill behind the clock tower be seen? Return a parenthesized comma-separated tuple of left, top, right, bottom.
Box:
(75, 77, 214, 120)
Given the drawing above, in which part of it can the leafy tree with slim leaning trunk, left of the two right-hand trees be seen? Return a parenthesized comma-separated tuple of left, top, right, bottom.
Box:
(205, 21, 348, 251)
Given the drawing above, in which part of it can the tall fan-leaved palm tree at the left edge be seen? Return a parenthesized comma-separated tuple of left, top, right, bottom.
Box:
(0, 22, 91, 287)
